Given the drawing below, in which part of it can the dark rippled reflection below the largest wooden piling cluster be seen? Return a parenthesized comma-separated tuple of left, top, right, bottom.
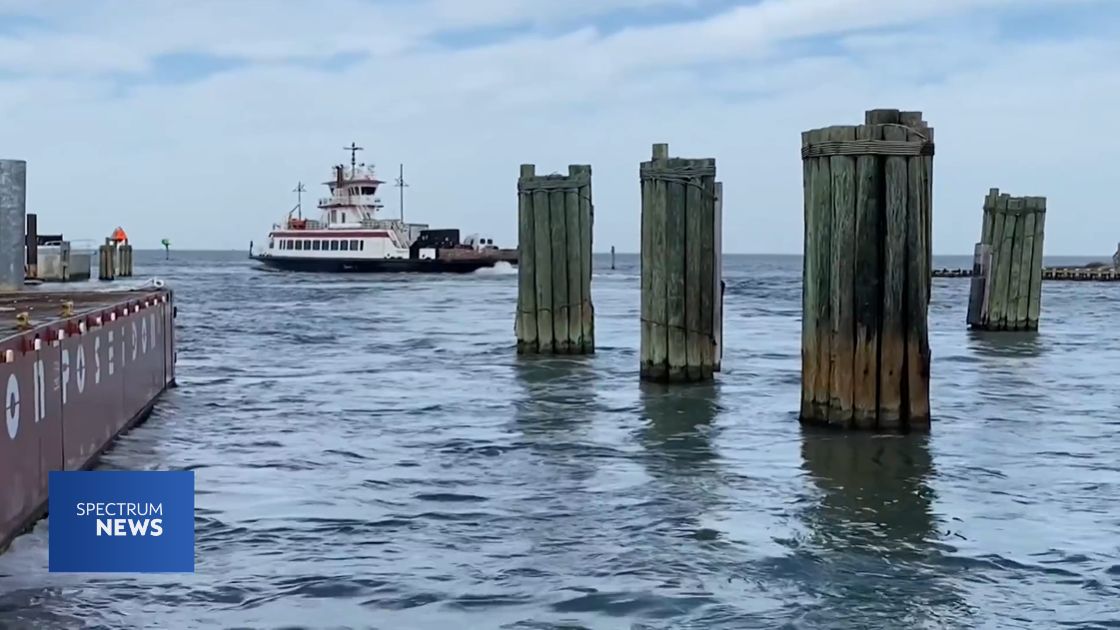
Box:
(801, 427, 964, 628)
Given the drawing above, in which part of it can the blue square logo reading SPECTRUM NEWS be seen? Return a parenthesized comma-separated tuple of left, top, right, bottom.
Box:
(47, 471, 195, 573)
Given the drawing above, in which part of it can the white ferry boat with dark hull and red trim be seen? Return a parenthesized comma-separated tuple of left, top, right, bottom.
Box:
(249, 142, 517, 272)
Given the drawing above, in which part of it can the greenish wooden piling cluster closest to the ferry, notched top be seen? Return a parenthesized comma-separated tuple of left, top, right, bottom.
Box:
(514, 164, 595, 354)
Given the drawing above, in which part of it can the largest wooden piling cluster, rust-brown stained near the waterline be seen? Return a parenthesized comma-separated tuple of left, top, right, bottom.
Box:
(801, 110, 933, 430)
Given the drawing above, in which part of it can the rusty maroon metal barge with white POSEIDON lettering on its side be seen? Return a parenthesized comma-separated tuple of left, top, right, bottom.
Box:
(0, 288, 176, 552)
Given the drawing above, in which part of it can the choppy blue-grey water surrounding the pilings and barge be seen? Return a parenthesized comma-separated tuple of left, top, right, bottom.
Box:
(0, 247, 1120, 629)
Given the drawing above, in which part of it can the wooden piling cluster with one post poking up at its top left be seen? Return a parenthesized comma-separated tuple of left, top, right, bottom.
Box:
(638, 145, 722, 382)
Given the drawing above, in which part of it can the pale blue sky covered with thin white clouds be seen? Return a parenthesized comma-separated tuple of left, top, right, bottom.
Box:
(0, 0, 1120, 256)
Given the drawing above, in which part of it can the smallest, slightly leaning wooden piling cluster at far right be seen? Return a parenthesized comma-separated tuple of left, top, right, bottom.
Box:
(968, 188, 1046, 331)
